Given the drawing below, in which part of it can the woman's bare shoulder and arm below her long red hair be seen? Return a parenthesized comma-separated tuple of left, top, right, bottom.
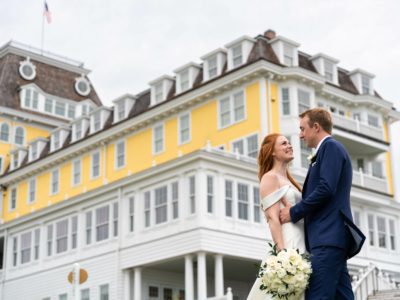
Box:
(260, 174, 285, 250)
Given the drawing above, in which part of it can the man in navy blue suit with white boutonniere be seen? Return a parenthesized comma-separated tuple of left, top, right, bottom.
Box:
(280, 108, 354, 300)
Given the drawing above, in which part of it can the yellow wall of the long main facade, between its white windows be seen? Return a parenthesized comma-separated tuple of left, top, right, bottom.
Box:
(3, 82, 266, 222)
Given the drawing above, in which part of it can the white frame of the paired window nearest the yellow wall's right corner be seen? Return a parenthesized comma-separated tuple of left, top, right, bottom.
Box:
(217, 89, 247, 130)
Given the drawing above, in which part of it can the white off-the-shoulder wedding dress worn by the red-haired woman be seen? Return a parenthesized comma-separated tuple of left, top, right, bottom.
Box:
(247, 185, 306, 300)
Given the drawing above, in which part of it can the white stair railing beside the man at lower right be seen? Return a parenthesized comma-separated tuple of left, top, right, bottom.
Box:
(353, 263, 396, 300)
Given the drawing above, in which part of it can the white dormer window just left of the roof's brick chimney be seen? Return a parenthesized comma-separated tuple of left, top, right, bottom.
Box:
(225, 36, 256, 70)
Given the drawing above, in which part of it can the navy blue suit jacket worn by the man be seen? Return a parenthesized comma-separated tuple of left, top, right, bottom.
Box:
(290, 137, 353, 252)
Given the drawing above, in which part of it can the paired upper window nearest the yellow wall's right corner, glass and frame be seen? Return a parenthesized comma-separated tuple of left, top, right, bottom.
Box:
(219, 91, 245, 128)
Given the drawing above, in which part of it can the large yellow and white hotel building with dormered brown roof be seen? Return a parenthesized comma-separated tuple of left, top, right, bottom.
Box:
(0, 30, 400, 300)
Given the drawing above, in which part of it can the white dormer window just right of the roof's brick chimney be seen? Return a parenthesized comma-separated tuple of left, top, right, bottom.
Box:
(270, 36, 300, 67)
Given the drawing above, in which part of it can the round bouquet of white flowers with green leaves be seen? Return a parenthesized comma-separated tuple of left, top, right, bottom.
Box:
(258, 244, 312, 300)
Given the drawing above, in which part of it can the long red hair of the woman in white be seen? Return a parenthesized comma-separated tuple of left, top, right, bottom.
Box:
(258, 133, 301, 192)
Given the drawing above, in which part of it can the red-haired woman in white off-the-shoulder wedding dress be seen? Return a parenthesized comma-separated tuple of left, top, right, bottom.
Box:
(247, 133, 306, 300)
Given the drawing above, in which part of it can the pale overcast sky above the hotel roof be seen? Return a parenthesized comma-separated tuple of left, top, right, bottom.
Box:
(0, 0, 400, 201)
